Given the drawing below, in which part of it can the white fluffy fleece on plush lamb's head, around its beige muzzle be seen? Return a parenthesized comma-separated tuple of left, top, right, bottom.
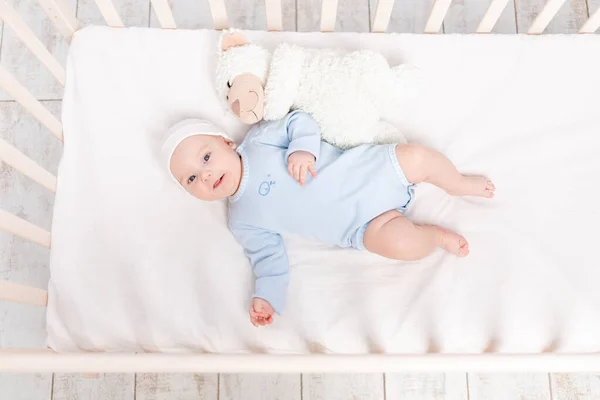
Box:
(215, 30, 271, 101)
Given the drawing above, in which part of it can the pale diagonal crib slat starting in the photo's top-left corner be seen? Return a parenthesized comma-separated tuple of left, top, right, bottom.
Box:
(0, 0, 66, 86)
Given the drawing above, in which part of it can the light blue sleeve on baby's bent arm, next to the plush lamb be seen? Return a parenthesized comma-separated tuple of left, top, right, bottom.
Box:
(285, 111, 321, 160)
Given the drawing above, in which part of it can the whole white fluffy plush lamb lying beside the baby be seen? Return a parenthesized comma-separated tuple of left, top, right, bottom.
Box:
(216, 30, 418, 148)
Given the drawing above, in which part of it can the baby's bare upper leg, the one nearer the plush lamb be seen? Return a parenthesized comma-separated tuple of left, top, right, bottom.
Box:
(396, 144, 496, 197)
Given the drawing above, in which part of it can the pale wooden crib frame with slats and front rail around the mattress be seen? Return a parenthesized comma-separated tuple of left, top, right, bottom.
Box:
(0, 0, 600, 373)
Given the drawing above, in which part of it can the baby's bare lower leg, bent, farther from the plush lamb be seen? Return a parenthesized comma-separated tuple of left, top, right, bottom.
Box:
(364, 210, 469, 261)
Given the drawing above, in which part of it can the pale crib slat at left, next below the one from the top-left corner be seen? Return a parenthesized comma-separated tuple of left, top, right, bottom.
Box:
(0, 66, 63, 140)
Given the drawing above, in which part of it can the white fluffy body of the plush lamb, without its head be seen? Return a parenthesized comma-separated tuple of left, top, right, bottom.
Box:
(264, 44, 413, 148)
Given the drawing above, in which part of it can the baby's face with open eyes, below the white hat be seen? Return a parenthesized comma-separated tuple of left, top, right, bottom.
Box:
(170, 135, 242, 200)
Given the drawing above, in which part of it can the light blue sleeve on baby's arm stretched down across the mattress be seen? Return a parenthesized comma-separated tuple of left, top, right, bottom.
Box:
(230, 224, 289, 315)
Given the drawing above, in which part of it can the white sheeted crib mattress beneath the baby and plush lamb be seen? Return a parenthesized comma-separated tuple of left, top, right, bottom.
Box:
(47, 27, 600, 353)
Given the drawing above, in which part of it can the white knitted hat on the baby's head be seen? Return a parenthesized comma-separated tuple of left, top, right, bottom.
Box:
(160, 118, 231, 185)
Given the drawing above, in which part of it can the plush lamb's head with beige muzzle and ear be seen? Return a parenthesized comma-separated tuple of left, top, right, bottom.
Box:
(216, 31, 270, 124)
